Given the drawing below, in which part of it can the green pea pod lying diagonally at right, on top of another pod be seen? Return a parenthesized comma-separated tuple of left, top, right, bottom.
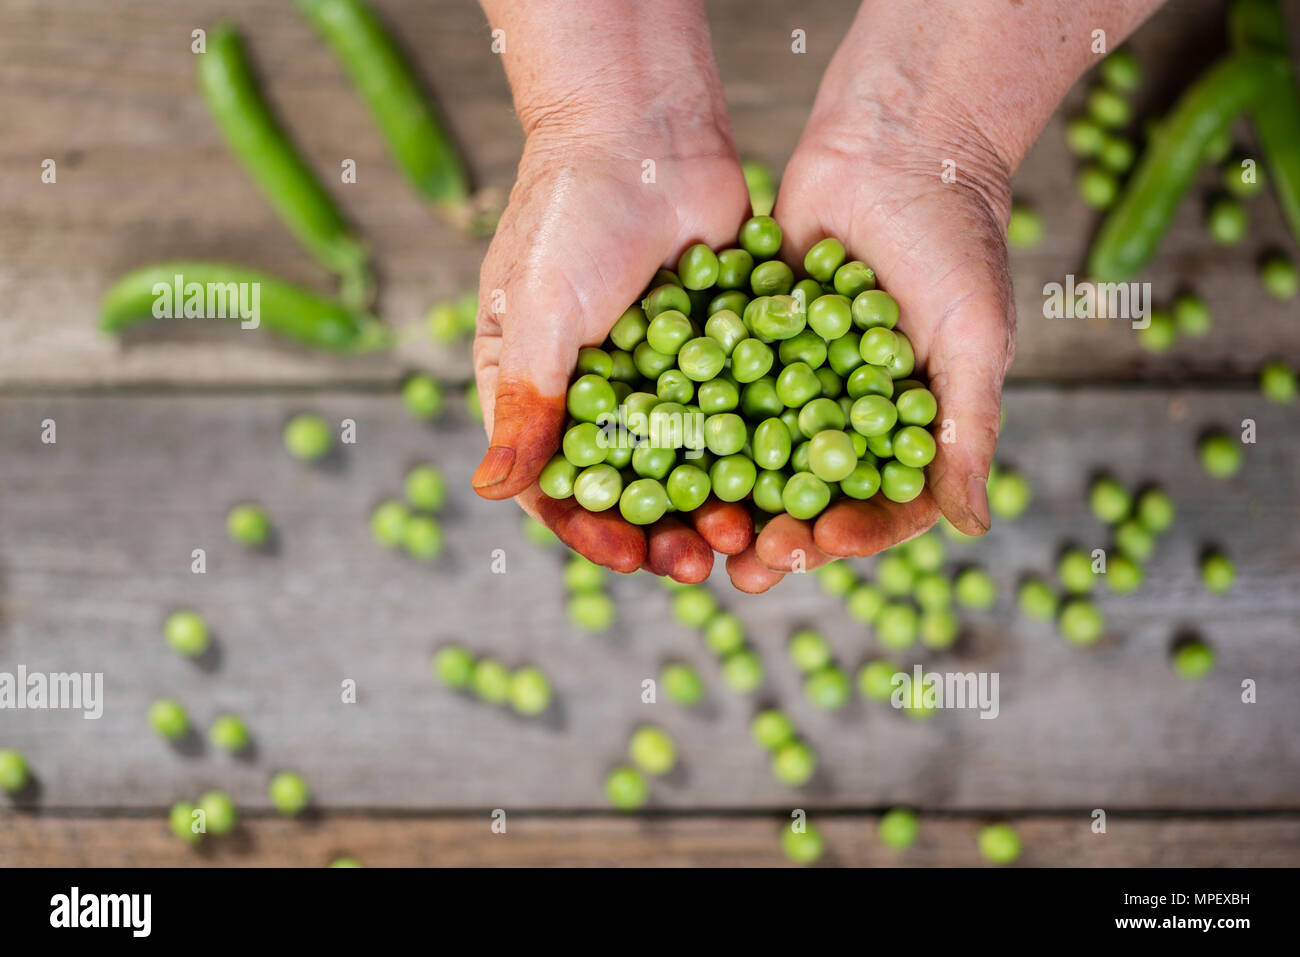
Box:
(1088, 53, 1286, 282)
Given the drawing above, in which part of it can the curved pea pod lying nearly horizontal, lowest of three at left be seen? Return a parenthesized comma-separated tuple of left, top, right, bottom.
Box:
(99, 261, 391, 352)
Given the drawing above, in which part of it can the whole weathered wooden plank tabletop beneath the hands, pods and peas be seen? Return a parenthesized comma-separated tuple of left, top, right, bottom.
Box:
(0, 0, 1300, 866)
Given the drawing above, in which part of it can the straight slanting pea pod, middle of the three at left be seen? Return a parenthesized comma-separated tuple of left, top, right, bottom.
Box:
(199, 25, 369, 304)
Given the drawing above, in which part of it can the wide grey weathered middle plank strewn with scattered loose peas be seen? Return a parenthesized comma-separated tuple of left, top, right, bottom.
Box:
(0, 389, 1300, 811)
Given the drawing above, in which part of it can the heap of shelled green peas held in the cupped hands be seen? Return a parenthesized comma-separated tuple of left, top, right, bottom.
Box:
(540, 216, 937, 525)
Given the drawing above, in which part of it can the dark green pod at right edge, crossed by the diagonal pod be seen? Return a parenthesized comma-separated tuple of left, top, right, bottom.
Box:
(1229, 0, 1300, 247)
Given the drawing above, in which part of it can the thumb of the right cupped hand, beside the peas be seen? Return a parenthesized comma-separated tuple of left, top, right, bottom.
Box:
(928, 290, 1015, 536)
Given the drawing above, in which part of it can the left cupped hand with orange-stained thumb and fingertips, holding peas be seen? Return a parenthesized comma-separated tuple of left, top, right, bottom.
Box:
(473, 122, 753, 583)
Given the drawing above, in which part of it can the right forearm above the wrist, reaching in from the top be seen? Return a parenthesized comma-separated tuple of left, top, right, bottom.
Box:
(811, 0, 1164, 173)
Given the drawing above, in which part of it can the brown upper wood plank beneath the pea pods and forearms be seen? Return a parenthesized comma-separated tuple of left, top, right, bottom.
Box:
(0, 0, 1300, 385)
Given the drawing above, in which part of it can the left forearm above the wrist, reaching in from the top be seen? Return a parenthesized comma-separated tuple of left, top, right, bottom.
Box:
(481, 0, 731, 151)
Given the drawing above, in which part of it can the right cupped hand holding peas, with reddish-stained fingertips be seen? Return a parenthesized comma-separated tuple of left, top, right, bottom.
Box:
(727, 110, 1015, 592)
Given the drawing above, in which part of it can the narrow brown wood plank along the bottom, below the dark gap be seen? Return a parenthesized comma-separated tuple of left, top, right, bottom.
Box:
(0, 811, 1300, 867)
